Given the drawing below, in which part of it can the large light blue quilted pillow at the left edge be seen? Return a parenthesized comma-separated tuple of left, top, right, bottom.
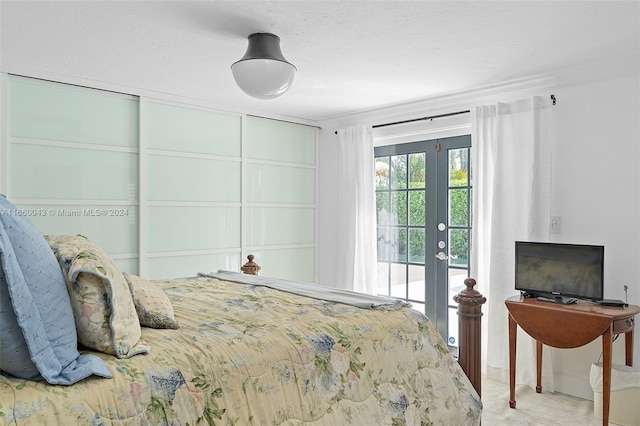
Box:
(0, 195, 112, 385)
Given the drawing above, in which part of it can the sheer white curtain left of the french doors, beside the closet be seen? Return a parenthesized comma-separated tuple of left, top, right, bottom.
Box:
(336, 126, 377, 294)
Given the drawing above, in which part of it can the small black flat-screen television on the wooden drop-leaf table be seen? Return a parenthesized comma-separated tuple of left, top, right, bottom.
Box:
(516, 241, 604, 300)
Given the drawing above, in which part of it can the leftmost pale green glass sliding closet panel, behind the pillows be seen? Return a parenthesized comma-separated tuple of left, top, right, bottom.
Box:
(3, 75, 139, 273)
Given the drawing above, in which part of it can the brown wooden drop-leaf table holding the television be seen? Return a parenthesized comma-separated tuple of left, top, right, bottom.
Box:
(505, 296, 640, 426)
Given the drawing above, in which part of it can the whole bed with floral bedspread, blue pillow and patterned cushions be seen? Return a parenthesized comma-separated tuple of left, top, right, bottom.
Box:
(0, 196, 482, 425)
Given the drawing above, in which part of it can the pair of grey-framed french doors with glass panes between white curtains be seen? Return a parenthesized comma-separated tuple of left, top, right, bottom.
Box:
(375, 135, 472, 351)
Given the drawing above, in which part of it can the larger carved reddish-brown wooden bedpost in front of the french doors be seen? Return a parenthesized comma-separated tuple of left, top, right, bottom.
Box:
(453, 278, 487, 396)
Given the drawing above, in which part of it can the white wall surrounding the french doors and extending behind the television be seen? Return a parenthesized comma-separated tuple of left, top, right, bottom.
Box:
(318, 70, 640, 398)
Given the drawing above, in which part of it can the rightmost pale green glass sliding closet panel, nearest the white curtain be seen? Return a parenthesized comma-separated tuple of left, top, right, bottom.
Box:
(242, 116, 316, 282)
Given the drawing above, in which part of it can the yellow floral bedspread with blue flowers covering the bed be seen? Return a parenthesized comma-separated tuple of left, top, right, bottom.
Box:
(0, 277, 482, 426)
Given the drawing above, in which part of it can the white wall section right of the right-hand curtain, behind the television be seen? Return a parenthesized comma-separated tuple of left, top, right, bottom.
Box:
(551, 75, 640, 398)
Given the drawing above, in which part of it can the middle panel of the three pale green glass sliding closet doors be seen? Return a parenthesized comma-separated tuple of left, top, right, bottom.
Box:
(141, 100, 241, 278)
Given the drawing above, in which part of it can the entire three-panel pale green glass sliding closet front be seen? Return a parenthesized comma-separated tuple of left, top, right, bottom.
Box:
(0, 74, 316, 282)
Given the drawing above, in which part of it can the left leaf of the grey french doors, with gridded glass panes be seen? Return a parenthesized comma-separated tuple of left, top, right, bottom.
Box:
(375, 142, 436, 320)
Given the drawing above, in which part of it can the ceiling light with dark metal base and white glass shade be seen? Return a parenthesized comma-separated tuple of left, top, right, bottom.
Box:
(231, 33, 296, 99)
